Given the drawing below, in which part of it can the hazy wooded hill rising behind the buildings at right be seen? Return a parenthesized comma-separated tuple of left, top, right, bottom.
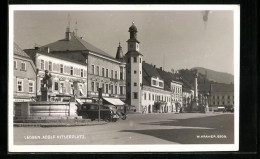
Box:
(192, 67, 234, 84)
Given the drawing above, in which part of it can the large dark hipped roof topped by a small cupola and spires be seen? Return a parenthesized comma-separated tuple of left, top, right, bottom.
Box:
(43, 34, 114, 59)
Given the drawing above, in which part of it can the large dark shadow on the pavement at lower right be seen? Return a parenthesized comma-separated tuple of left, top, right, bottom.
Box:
(121, 115, 234, 144)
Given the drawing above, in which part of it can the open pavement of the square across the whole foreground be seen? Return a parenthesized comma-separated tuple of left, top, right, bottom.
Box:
(14, 113, 234, 145)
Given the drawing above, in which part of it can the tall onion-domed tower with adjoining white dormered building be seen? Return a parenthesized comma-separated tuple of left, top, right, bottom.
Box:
(125, 23, 173, 113)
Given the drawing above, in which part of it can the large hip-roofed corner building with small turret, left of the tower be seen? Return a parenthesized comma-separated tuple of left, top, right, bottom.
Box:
(25, 24, 126, 100)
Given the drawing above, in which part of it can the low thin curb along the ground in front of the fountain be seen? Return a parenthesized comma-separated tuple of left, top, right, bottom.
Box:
(13, 121, 108, 127)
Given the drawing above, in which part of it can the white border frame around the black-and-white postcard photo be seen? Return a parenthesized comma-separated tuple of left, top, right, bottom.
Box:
(8, 5, 240, 152)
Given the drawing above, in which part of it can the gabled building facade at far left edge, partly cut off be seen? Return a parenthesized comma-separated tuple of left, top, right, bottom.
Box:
(13, 43, 37, 102)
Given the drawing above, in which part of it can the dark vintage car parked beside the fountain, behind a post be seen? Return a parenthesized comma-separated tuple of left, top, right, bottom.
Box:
(77, 103, 119, 121)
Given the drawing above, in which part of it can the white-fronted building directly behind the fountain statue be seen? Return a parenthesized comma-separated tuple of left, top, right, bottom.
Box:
(25, 48, 87, 98)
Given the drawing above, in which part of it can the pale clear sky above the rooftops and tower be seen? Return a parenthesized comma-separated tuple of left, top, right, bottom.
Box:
(14, 10, 234, 75)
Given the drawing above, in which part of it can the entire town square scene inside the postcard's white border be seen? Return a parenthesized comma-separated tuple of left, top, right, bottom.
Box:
(9, 5, 238, 151)
